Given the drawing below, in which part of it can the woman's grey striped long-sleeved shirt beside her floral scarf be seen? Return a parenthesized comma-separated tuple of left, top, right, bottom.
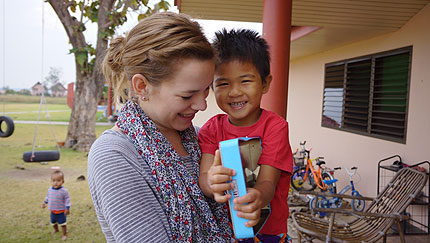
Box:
(88, 130, 171, 242)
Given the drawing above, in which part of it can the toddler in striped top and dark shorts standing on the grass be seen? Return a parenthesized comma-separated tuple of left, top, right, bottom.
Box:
(42, 170, 70, 240)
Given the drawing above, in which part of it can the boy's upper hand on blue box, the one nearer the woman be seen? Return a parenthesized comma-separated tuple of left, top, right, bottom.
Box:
(208, 150, 236, 203)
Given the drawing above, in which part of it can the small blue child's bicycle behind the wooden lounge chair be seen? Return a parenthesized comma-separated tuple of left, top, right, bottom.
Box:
(309, 166, 366, 216)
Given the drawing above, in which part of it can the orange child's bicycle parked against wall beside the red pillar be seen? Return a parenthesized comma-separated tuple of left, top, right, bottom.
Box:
(291, 141, 336, 192)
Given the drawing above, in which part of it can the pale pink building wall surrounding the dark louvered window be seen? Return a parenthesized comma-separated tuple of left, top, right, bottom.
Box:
(287, 5, 430, 196)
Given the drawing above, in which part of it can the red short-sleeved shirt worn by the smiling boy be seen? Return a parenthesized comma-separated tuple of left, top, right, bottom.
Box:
(198, 110, 293, 235)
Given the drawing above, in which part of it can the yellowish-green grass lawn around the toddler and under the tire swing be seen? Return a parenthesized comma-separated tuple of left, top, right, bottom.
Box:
(0, 123, 111, 242)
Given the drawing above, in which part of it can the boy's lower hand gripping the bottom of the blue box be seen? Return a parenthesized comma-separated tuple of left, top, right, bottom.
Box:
(233, 187, 264, 227)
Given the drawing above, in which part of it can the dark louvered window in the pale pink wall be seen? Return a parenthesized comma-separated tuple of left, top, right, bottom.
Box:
(321, 46, 412, 143)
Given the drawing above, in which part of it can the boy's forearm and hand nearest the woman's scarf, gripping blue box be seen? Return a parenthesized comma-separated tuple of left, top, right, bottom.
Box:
(199, 150, 234, 202)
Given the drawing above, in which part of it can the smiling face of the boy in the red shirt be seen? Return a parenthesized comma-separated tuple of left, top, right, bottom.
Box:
(213, 60, 271, 126)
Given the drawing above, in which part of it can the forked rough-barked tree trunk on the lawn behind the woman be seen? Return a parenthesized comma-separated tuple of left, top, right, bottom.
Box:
(49, 0, 114, 151)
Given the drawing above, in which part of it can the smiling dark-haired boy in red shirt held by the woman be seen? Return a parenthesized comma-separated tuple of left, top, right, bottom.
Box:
(198, 29, 293, 242)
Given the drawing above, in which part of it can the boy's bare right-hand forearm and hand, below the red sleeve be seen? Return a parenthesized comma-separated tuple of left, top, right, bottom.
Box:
(233, 164, 281, 227)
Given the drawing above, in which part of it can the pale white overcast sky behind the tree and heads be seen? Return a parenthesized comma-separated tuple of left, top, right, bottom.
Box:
(0, 0, 262, 90)
